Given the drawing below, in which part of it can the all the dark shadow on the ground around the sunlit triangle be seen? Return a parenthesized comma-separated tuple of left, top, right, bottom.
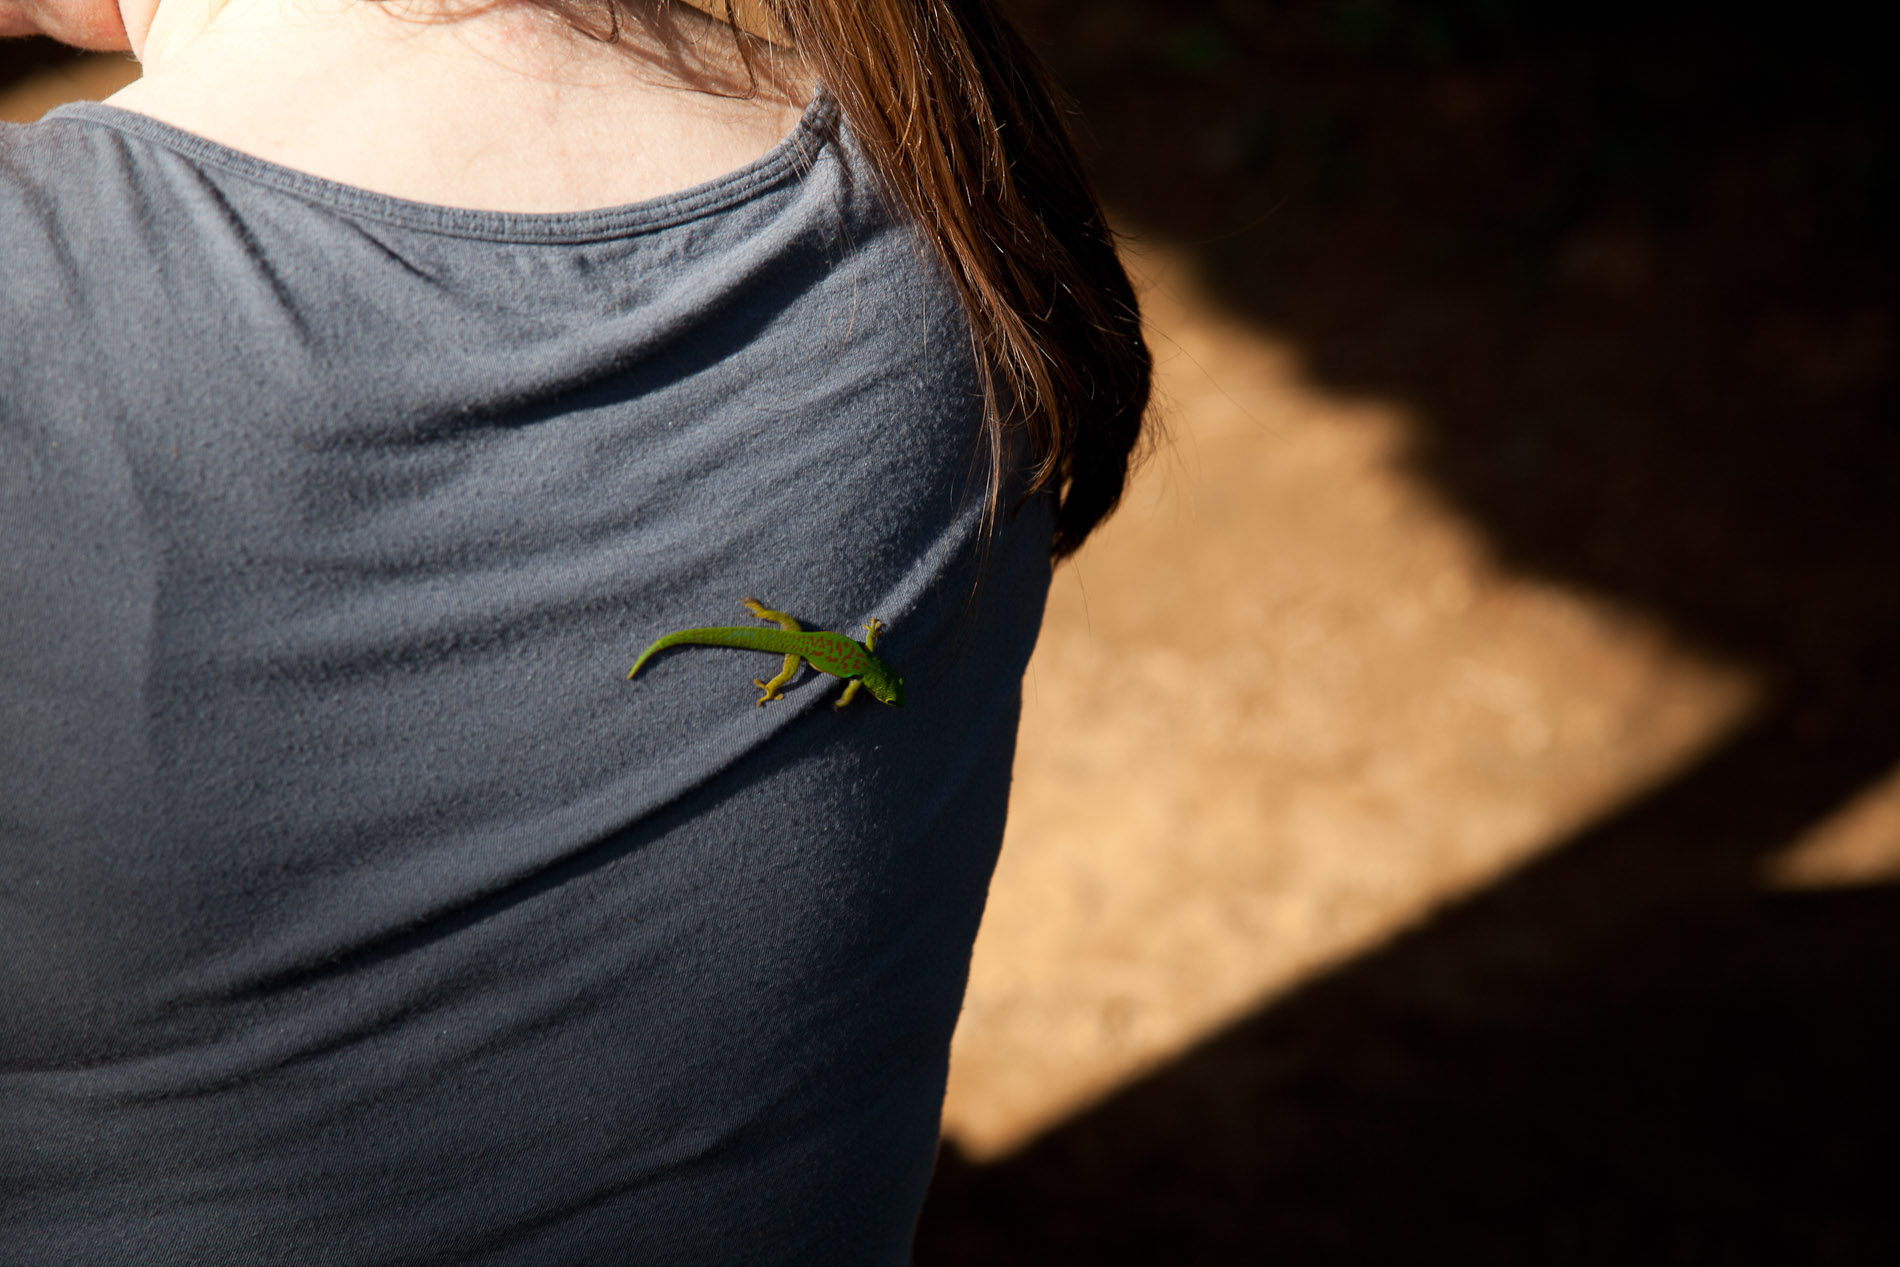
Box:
(918, 0, 1900, 1267)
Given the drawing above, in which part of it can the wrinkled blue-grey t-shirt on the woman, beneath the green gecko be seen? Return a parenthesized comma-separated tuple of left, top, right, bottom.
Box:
(0, 95, 1049, 1267)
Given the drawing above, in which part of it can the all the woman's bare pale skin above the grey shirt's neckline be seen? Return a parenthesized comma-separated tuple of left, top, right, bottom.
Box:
(0, 0, 809, 211)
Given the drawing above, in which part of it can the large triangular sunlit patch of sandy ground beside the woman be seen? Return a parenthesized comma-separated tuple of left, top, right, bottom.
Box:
(944, 237, 1758, 1159)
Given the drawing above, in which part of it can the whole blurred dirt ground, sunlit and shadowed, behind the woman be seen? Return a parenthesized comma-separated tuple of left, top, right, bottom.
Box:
(0, 0, 1900, 1267)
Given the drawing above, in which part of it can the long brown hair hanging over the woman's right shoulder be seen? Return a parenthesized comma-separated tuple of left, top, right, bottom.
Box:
(570, 0, 1151, 558)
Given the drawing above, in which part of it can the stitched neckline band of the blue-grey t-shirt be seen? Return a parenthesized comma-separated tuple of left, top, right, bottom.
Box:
(42, 87, 838, 243)
